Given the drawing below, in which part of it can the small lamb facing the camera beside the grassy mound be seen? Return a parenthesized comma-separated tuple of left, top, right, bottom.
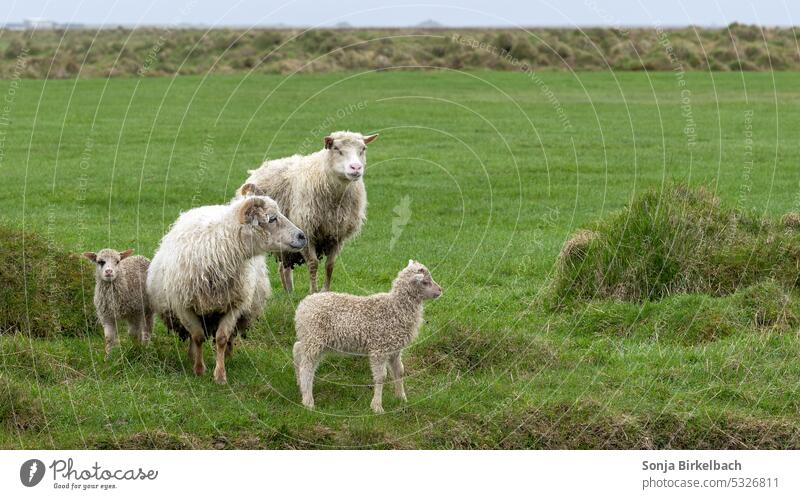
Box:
(83, 249, 153, 356)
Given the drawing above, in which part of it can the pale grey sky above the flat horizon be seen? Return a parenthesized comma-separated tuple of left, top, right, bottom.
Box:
(0, 0, 800, 27)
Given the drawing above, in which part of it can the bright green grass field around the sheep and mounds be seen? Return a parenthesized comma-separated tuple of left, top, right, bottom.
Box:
(0, 71, 800, 448)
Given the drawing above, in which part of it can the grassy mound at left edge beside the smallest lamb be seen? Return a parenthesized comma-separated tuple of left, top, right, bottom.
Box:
(0, 225, 96, 337)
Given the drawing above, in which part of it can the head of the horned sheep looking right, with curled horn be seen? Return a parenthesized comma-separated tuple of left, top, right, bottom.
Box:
(237, 196, 306, 254)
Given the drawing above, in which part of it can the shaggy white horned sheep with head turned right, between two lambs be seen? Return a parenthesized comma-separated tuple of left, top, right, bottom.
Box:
(147, 196, 306, 384)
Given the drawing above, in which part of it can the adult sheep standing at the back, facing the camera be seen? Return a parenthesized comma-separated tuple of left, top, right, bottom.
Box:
(238, 131, 378, 293)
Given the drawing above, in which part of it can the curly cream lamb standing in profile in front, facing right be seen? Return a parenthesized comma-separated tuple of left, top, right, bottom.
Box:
(293, 260, 442, 414)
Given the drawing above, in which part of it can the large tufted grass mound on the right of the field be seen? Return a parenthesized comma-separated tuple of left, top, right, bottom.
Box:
(553, 184, 800, 305)
